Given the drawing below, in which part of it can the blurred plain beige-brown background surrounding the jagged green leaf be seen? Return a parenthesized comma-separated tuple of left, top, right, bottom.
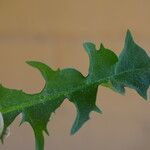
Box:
(0, 0, 150, 150)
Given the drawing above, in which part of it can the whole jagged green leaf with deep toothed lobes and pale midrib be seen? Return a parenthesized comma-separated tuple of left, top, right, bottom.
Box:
(0, 30, 150, 150)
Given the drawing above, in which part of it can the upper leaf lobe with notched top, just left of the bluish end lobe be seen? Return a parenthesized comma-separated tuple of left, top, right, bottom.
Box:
(84, 43, 118, 82)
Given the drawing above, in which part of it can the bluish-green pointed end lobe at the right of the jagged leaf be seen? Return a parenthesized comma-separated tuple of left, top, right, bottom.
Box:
(111, 30, 150, 99)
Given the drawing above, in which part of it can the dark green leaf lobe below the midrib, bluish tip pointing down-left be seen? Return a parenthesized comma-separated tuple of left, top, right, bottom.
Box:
(68, 86, 102, 134)
